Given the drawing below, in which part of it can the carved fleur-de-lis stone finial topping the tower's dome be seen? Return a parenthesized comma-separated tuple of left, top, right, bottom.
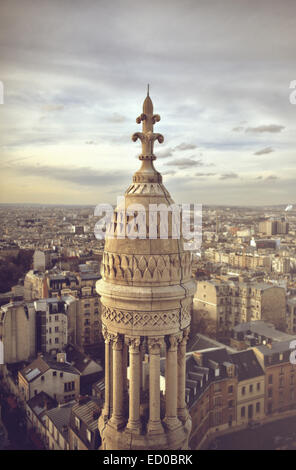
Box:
(132, 85, 164, 183)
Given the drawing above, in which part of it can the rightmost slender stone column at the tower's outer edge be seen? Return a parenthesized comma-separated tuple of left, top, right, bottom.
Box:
(177, 328, 189, 422)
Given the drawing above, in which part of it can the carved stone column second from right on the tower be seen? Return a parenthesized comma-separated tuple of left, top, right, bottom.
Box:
(164, 335, 181, 429)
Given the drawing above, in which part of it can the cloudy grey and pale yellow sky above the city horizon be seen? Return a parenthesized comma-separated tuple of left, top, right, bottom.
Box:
(0, 0, 296, 205)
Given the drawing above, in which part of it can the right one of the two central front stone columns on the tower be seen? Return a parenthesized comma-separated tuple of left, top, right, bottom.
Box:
(147, 336, 163, 434)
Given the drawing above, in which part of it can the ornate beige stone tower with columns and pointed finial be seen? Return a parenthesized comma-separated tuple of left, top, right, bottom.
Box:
(97, 89, 195, 450)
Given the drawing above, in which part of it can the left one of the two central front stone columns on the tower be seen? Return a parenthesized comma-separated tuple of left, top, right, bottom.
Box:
(126, 337, 141, 433)
